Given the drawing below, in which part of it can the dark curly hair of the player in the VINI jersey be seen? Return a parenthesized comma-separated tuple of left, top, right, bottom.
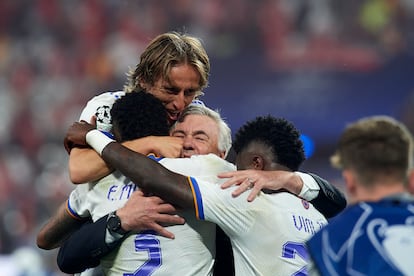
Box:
(233, 115, 305, 171)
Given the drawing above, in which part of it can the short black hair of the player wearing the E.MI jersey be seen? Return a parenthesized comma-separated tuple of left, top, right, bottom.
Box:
(111, 92, 169, 142)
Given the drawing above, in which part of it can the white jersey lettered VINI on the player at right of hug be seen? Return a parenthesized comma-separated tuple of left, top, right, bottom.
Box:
(191, 171, 327, 276)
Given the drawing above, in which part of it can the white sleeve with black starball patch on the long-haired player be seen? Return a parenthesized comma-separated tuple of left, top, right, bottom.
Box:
(79, 91, 125, 133)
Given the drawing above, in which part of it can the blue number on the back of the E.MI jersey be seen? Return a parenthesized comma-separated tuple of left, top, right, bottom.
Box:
(124, 231, 162, 276)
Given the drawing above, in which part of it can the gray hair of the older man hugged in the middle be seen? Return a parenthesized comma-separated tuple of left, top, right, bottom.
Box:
(172, 104, 231, 157)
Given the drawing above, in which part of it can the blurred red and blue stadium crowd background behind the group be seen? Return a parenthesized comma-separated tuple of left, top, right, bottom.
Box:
(0, 0, 414, 275)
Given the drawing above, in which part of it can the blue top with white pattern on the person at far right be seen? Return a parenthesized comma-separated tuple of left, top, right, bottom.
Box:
(308, 198, 414, 276)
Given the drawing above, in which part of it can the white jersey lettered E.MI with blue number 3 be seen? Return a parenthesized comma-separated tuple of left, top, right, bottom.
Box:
(68, 154, 235, 276)
